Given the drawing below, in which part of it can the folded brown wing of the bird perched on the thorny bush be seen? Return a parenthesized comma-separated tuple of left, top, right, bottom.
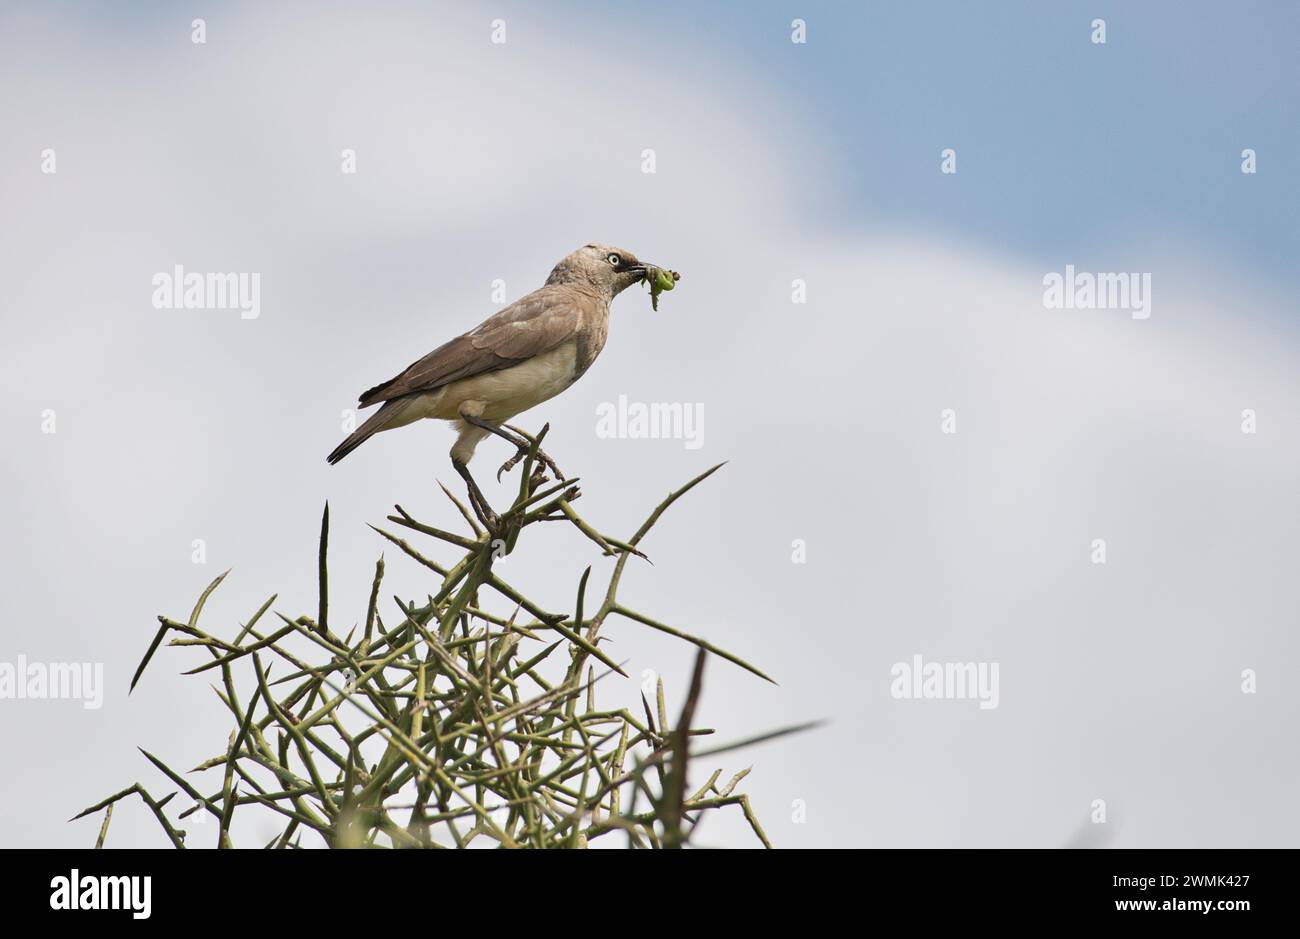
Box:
(360, 285, 586, 407)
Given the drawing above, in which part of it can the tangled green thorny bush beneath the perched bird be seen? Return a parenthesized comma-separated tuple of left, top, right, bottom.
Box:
(77, 428, 809, 848)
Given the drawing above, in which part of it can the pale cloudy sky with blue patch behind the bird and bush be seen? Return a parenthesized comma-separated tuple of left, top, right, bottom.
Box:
(0, 3, 1300, 848)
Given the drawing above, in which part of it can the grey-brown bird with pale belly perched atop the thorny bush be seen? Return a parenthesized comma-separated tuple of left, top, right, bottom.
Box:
(326, 243, 680, 529)
